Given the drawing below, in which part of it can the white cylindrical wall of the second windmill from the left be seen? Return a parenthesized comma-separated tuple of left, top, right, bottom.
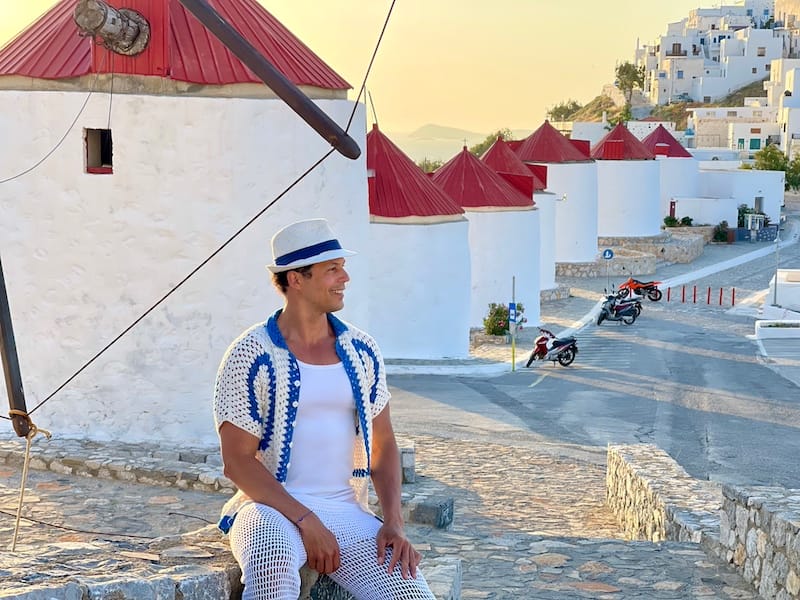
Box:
(369, 219, 470, 359)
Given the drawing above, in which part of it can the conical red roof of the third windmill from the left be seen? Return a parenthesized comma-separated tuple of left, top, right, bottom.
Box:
(433, 146, 533, 208)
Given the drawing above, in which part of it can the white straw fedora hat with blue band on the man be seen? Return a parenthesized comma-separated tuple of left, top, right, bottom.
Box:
(267, 219, 355, 273)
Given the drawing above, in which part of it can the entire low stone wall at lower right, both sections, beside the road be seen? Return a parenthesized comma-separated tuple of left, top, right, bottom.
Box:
(606, 444, 800, 600)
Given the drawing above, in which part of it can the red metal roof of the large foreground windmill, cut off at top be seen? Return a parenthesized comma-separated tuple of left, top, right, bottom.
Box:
(0, 0, 351, 90)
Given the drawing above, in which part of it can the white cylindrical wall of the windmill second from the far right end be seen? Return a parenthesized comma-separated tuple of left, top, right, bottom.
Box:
(597, 160, 662, 237)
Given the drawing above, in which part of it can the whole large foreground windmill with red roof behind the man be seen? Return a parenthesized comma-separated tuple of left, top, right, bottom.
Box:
(0, 0, 371, 446)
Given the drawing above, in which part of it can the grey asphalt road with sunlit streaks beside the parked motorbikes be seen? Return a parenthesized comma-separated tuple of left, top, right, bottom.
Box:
(389, 204, 800, 488)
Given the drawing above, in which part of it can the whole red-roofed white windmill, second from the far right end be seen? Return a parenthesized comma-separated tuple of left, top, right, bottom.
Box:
(592, 123, 663, 238)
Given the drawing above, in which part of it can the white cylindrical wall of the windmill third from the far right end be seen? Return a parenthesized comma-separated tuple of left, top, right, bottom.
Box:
(552, 162, 597, 263)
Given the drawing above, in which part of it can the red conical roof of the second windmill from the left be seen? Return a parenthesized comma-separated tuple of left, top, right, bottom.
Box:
(367, 125, 464, 218)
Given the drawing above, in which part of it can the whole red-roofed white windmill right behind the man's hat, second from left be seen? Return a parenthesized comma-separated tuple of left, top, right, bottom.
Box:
(367, 125, 470, 359)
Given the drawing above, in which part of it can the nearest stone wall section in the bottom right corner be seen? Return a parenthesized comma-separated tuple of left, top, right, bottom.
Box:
(720, 486, 800, 600)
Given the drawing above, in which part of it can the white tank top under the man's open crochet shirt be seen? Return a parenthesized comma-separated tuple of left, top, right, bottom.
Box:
(286, 361, 356, 501)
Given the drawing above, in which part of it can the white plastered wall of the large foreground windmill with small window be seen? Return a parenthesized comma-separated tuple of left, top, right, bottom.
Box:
(0, 91, 370, 445)
